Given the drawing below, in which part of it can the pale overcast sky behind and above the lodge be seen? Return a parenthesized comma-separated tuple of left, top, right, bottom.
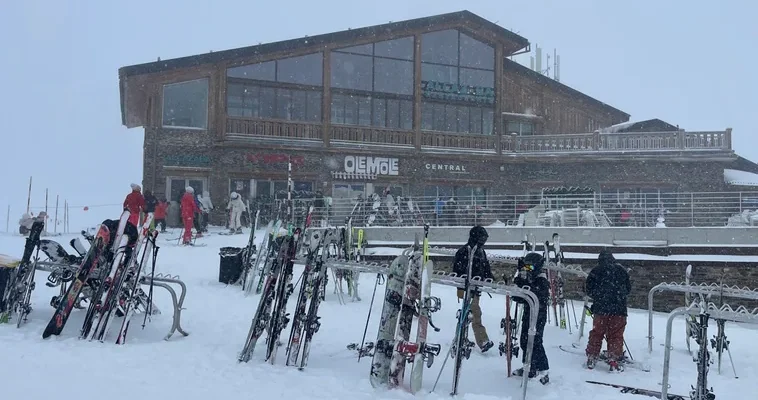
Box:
(0, 0, 758, 230)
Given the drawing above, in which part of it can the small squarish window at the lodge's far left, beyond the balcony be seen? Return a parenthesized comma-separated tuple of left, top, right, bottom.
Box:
(163, 78, 208, 129)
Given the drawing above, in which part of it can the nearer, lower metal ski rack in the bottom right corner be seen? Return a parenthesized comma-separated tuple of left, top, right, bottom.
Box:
(664, 302, 758, 400)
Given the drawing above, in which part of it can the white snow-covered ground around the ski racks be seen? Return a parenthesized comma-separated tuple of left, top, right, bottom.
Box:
(0, 230, 758, 400)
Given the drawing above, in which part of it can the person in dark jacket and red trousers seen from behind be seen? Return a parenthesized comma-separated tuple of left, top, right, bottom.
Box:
(585, 250, 632, 371)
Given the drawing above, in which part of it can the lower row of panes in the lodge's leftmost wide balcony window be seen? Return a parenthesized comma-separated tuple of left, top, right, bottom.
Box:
(226, 82, 321, 121)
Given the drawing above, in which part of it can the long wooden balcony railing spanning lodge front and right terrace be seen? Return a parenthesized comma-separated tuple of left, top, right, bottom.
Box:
(226, 117, 732, 156)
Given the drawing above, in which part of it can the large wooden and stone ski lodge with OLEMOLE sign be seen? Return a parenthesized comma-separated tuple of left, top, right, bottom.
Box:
(119, 11, 758, 225)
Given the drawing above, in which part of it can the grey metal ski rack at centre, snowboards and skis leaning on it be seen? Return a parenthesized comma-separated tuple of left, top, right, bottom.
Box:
(308, 255, 539, 400)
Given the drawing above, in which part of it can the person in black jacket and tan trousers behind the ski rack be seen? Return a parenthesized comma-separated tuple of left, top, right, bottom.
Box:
(453, 225, 494, 353)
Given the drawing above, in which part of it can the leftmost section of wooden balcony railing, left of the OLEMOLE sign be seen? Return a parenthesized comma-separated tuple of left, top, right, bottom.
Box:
(226, 117, 323, 140)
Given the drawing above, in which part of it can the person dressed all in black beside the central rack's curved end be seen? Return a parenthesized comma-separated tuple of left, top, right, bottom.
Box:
(513, 253, 550, 384)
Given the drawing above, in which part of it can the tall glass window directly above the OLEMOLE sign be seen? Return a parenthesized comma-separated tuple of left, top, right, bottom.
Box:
(331, 37, 414, 130)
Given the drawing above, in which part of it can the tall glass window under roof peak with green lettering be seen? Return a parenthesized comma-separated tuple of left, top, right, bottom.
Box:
(421, 29, 495, 134)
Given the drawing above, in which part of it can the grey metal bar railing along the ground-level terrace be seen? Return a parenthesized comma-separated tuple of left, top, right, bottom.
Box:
(248, 188, 758, 227)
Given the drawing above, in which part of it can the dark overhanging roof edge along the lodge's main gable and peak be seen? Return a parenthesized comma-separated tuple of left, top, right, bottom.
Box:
(119, 10, 529, 77)
